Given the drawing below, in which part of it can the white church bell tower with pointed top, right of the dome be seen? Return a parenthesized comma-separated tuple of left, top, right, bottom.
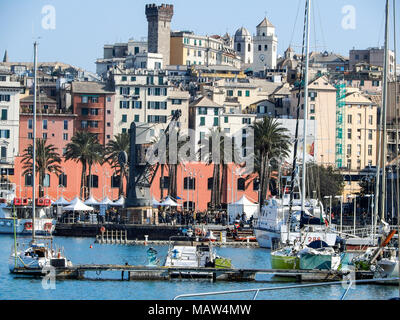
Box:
(253, 18, 278, 72)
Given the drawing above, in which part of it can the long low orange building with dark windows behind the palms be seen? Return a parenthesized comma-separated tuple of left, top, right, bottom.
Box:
(13, 157, 258, 211)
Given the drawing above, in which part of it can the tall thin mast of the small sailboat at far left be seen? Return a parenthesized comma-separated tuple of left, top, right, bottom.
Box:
(32, 41, 37, 243)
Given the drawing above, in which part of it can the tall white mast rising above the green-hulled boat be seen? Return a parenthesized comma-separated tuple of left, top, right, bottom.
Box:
(301, 0, 311, 211)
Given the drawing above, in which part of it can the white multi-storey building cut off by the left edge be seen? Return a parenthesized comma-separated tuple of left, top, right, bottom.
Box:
(0, 71, 21, 173)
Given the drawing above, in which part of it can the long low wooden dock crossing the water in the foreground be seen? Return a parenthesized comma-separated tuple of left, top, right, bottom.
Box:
(10, 264, 372, 282)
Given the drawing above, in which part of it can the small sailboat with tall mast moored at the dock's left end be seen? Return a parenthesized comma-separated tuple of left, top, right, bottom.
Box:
(9, 42, 72, 276)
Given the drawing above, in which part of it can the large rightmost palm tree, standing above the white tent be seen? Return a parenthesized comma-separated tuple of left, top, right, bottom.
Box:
(252, 117, 290, 205)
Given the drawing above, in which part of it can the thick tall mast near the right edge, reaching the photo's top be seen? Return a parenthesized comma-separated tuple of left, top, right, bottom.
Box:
(381, 0, 389, 221)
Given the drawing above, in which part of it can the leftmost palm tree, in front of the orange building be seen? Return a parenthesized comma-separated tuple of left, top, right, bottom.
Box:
(22, 139, 62, 197)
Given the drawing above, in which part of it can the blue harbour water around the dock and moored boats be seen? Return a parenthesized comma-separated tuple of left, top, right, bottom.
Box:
(0, 235, 398, 300)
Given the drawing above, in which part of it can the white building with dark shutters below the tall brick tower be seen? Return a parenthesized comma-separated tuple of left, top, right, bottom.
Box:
(111, 68, 190, 137)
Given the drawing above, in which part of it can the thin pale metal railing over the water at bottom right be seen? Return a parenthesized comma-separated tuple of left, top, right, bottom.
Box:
(174, 278, 400, 300)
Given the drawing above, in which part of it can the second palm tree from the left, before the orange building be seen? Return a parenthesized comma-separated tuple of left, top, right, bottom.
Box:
(65, 131, 102, 198)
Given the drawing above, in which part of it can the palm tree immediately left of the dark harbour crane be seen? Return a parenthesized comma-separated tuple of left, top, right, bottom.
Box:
(105, 132, 130, 196)
